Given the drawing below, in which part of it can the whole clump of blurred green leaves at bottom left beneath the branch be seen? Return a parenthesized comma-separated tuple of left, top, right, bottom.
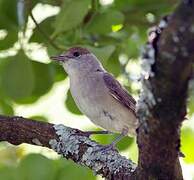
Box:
(0, 154, 96, 180)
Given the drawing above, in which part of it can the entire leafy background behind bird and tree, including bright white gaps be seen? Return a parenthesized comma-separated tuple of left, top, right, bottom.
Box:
(0, 0, 194, 180)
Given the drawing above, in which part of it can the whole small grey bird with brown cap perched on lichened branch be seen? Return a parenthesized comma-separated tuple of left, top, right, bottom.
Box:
(51, 47, 138, 148)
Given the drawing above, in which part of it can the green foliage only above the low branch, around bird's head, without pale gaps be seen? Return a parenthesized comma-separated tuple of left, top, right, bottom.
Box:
(0, 0, 176, 114)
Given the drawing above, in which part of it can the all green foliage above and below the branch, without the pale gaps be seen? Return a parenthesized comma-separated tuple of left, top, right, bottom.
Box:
(0, 0, 194, 180)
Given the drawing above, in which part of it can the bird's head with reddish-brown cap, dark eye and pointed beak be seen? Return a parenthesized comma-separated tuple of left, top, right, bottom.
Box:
(51, 47, 103, 75)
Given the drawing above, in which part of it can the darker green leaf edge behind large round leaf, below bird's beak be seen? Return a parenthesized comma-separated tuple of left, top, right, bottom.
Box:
(31, 61, 55, 97)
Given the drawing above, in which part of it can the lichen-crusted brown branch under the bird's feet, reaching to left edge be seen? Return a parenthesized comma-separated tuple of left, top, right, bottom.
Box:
(0, 116, 136, 179)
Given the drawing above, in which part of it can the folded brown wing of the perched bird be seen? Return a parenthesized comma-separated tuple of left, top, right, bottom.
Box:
(103, 73, 136, 115)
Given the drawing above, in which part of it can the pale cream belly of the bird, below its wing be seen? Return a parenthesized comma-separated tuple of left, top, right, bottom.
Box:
(71, 89, 137, 135)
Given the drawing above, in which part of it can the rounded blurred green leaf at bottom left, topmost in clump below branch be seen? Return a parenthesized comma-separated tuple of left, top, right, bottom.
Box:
(18, 154, 56, 180)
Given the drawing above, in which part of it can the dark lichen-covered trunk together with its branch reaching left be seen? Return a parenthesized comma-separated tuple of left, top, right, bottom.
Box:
(0, 0, 194, 180)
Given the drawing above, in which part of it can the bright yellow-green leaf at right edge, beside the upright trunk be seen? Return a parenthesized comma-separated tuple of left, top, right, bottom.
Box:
(181, 128, 194, 163)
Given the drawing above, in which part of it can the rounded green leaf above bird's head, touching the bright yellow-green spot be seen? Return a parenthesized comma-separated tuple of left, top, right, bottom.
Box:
(86, 10, 124, 34)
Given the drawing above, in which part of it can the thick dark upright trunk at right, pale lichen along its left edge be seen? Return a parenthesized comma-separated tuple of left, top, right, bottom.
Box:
(135, 1, 194, 180)
